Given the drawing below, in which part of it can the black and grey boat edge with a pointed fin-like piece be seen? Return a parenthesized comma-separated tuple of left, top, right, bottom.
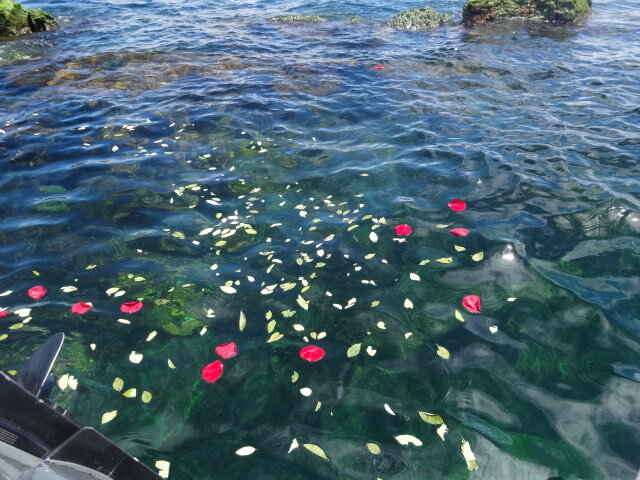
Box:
(0, 333, 160, 480)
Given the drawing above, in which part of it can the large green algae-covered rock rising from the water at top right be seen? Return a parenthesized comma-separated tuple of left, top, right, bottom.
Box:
(462, 0, 591, 25)
